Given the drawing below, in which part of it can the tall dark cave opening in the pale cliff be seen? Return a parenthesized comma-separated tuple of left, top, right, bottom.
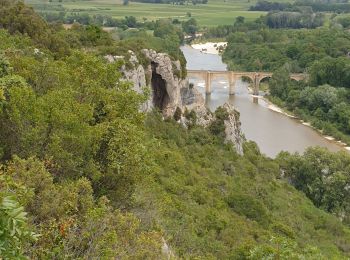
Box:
(151, 62, 169, 111)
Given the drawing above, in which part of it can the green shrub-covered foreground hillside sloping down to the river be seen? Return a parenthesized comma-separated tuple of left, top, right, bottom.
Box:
(0, 0, 350, 259)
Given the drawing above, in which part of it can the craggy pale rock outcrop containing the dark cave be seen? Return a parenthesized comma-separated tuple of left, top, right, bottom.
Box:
(106, 49, 204, 117)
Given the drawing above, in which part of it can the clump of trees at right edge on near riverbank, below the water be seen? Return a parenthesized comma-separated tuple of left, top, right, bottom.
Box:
(278, 148, 350, 224)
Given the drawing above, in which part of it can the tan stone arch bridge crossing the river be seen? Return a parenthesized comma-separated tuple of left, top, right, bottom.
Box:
(187, 70, 307, 95)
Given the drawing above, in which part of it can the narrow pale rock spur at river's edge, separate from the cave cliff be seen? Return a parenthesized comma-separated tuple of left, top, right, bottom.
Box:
(223, 103, 244, 155)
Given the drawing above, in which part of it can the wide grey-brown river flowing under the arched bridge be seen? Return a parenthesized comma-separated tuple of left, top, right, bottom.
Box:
(181, 46, 344, 158)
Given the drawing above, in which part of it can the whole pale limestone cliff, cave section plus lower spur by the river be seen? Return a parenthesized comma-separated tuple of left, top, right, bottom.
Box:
(106, 50, 243, 154)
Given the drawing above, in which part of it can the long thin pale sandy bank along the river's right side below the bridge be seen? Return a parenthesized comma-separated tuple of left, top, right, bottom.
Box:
(259, 96, 350, 151)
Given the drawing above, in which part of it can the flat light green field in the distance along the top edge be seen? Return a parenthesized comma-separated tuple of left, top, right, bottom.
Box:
(26, 0, 265, 26)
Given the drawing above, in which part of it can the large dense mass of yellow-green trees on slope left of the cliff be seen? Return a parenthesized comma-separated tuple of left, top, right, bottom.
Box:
(0, 27, 147, 207)
